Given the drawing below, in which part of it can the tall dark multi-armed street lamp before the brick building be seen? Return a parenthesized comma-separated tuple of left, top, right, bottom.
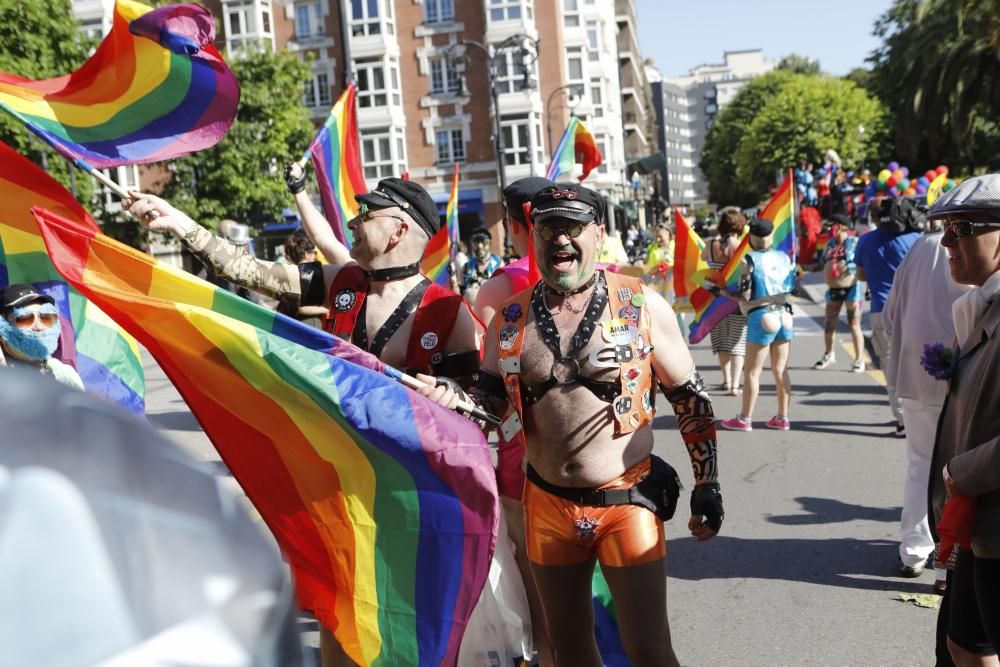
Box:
(444, 33, 538, 254)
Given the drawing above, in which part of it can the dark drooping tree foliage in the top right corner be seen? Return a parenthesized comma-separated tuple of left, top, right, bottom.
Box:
(869, 0, 1000, 172)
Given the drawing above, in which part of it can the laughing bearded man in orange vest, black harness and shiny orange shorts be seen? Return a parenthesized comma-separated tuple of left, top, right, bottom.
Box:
(425, 185, 724, 667)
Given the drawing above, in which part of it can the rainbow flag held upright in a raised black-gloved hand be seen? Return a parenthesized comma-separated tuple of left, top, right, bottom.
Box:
(303, 81, 368, 248)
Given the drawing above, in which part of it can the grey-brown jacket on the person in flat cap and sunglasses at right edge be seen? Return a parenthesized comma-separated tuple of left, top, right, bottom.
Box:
(928, 299, 1000, 558)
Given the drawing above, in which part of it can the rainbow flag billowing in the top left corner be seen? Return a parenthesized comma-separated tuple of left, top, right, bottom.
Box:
(0, 0, 240, 171)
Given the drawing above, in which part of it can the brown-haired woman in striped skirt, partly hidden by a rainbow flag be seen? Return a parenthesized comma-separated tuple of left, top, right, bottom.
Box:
(701, 206, 747, 396)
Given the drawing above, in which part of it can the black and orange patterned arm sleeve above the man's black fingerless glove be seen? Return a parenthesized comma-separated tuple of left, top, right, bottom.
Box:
(660, 370, 719, 482)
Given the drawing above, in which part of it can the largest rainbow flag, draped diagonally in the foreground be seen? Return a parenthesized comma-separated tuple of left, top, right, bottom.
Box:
(34, 208, 499, 665)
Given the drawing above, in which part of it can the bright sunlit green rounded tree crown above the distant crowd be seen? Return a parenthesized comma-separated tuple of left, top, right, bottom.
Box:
(734, 75, 886, 194)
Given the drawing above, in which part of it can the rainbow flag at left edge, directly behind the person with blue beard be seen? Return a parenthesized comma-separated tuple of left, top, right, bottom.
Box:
(0, 142, 146, 414)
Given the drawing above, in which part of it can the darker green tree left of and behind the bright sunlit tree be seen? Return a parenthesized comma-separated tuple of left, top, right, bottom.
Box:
(698, 70, 795, 207)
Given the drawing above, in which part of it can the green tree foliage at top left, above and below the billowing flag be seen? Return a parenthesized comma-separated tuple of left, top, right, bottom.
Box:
(0, 0, 95, 203)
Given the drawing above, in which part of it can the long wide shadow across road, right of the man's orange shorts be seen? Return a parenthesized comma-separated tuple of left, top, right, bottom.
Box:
(667, 535, 930, 593)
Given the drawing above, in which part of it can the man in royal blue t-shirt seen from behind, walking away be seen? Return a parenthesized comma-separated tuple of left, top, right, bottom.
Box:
(854, 198, 927, 438)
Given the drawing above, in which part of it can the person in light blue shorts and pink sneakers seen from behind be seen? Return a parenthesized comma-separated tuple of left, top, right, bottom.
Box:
(722, 218, 795, 431)
